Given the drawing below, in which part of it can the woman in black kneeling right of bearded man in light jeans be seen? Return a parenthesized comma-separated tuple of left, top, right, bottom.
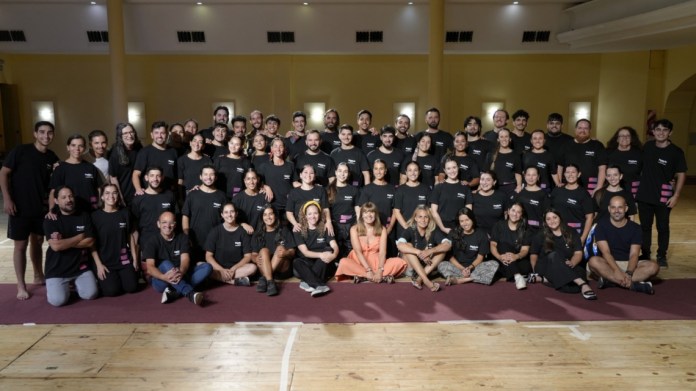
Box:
(90, 184, 140, 296)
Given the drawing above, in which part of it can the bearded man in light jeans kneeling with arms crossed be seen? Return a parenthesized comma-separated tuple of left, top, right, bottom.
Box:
(44, 186, 99, 307)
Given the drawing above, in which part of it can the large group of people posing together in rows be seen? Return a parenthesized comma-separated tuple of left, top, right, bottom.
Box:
(0, 106, 687, 306)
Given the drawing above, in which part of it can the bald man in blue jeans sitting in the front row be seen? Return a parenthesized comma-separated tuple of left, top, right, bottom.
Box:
(143, 212, 213, 305)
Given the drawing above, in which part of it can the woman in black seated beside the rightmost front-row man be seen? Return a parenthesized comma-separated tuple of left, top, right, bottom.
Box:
(527, 209, 597, 300)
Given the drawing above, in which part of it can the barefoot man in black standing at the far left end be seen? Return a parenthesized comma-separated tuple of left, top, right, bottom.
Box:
(0, 121, 58, 300)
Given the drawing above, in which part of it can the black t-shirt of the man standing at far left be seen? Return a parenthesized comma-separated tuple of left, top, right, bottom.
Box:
(3, 144, 58, 218)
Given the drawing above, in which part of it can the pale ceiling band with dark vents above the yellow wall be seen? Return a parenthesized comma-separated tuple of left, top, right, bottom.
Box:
(0, 0, 696, 54)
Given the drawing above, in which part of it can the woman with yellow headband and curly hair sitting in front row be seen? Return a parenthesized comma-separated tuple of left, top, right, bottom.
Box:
(293, 201, 338, 297)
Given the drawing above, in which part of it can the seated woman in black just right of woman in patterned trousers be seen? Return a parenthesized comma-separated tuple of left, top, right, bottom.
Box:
(491, 202, 532, 289)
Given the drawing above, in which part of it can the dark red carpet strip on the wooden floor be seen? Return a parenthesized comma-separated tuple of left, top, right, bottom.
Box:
(0, 279, 696, 324)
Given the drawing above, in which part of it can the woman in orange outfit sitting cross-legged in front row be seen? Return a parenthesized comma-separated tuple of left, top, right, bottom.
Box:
(336, 202, 406, 284)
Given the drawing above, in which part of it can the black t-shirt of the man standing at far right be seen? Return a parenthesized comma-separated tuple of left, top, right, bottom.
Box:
(636, 141, 687, 205)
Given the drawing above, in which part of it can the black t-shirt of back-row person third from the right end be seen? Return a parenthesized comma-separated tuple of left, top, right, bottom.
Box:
(561, 140, 607, 190)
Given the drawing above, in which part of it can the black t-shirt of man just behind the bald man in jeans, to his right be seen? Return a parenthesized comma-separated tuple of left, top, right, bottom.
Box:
(181, 190, 227, 247)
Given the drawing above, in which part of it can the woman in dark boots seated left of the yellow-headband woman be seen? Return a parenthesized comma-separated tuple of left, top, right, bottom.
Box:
(251, 204, 295, 296)
